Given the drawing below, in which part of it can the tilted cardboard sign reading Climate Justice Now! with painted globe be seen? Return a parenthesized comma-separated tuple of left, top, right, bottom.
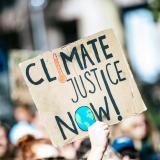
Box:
(20, 29, 146, 146)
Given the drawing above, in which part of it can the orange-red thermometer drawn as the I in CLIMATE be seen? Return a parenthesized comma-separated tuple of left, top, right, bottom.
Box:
(53, 53, 67, 83)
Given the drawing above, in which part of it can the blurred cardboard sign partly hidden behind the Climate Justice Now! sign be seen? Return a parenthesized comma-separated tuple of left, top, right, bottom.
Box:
(9, 50, 37, 103)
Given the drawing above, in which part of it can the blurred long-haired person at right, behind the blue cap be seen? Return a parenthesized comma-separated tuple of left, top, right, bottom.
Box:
(119, 114, 160, 160)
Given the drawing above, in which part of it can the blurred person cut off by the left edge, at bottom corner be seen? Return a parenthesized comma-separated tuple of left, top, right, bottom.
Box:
(0, 122, 14, 160)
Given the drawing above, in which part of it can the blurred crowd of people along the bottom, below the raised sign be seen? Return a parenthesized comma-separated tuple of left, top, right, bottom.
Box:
(0, 103, 160, 160)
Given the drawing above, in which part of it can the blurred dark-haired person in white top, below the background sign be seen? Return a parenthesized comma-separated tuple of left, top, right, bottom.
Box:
(9, 102, 44, 145)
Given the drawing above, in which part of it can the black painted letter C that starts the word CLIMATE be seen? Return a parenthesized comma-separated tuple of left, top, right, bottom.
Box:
(26, 63, 44, 85)
